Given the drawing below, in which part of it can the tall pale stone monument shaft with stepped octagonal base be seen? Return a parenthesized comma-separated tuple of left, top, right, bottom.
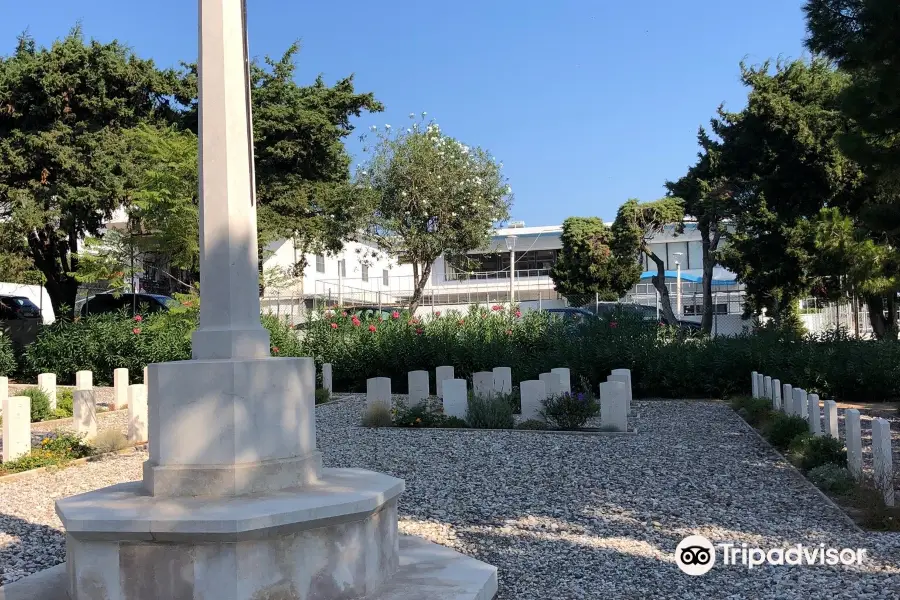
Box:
(56, 0, 497, 600)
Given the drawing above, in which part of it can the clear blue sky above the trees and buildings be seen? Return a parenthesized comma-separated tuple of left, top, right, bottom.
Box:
(0, 0, 804, 225)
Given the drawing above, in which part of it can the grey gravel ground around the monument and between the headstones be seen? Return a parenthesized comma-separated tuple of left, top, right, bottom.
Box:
(0, 397, 900, 600)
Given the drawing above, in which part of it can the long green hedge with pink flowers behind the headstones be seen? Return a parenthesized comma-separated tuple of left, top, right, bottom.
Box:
(19, 307, 900, 401)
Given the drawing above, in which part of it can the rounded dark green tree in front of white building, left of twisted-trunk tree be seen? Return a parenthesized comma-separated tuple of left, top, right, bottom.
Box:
(550, 217, 641, 304)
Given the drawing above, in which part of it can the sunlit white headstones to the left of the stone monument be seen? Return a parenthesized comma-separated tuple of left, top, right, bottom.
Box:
(0, 368, 148, 462)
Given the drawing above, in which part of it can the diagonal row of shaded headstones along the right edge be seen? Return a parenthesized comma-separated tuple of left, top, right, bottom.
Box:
(751, 371, 895, 506)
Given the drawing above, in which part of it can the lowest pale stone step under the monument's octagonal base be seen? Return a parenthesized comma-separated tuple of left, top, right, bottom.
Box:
(0, 535, 497, 600)
